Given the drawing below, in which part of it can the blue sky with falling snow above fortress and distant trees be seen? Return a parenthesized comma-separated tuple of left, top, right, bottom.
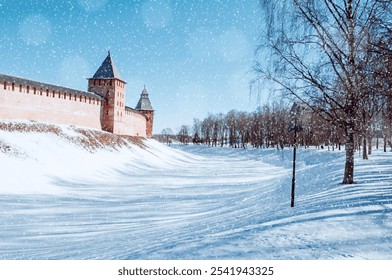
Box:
(0, 0, 261, 133)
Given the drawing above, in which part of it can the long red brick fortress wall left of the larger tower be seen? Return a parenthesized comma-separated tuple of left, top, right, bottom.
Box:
(0, 84, 102, 130)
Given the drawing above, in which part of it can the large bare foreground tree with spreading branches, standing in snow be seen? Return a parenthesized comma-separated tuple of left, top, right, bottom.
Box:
(255, 0, 390, 184)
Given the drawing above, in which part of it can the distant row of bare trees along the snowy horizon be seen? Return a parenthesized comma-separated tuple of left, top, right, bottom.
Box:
(156, 99, 392, 153)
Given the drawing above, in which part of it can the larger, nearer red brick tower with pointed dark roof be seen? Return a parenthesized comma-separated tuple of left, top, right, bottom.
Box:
(88, 52, 126, 134)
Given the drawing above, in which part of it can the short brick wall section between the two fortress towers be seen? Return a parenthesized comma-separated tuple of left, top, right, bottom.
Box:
(117, 109, 146, 137)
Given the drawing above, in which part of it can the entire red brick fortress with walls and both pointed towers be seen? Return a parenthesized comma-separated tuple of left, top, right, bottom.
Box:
(0, 52, 154, 138)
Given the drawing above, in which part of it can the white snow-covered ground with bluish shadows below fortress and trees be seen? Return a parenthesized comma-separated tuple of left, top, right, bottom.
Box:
(0, 123, 392, 259)
